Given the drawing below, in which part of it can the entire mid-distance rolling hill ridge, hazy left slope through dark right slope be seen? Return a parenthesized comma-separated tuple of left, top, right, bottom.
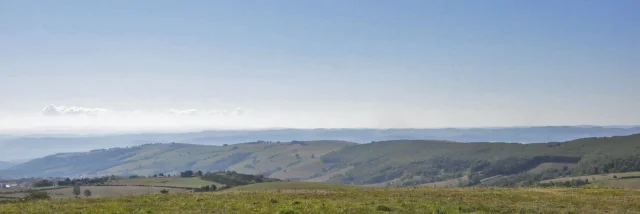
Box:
(0, 134, 640, 186)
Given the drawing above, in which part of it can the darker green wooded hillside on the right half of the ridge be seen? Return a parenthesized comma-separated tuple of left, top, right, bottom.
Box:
(322, 134, 640, 186)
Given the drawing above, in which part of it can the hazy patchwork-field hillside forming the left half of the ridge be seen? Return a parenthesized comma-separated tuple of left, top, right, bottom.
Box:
(5, 141, 352, 179)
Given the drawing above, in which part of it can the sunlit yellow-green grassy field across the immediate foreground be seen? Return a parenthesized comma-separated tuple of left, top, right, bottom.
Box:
(0, 186, 640, 213)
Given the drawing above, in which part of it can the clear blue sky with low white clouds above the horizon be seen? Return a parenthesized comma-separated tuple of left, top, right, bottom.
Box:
(0, 0, 640, 132)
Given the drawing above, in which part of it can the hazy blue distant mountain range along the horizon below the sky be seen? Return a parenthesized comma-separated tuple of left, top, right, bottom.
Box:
(0, 126, 640, 161)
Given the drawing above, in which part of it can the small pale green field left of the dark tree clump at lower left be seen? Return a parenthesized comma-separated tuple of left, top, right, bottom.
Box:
(107, 177, 222, 188)
